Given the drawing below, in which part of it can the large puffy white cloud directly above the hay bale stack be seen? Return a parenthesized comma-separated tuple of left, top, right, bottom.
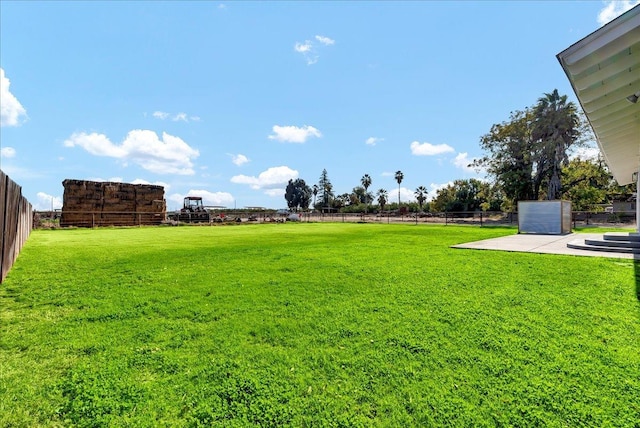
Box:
(64, 129, 200, 175)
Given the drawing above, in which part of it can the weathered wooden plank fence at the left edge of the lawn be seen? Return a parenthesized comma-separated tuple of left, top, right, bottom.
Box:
(0, 170, 33, 283)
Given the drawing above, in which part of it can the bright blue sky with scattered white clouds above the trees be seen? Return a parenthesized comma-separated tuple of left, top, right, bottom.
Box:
(0, 0, 637, 209)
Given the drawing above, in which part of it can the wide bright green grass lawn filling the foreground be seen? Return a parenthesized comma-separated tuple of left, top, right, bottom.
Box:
(0, 223, 640, 427)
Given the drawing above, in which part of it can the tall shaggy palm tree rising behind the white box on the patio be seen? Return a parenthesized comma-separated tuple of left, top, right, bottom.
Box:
(532, 89, 580, 199)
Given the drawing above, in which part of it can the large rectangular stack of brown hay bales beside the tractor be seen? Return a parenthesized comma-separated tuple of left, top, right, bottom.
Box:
(60, 180, 166, 227)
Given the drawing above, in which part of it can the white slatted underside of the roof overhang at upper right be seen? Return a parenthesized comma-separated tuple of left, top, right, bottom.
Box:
(557, 5, 640, 185)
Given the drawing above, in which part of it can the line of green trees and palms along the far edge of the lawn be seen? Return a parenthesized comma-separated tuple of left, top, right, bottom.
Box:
(285, 89, 636, 213)
